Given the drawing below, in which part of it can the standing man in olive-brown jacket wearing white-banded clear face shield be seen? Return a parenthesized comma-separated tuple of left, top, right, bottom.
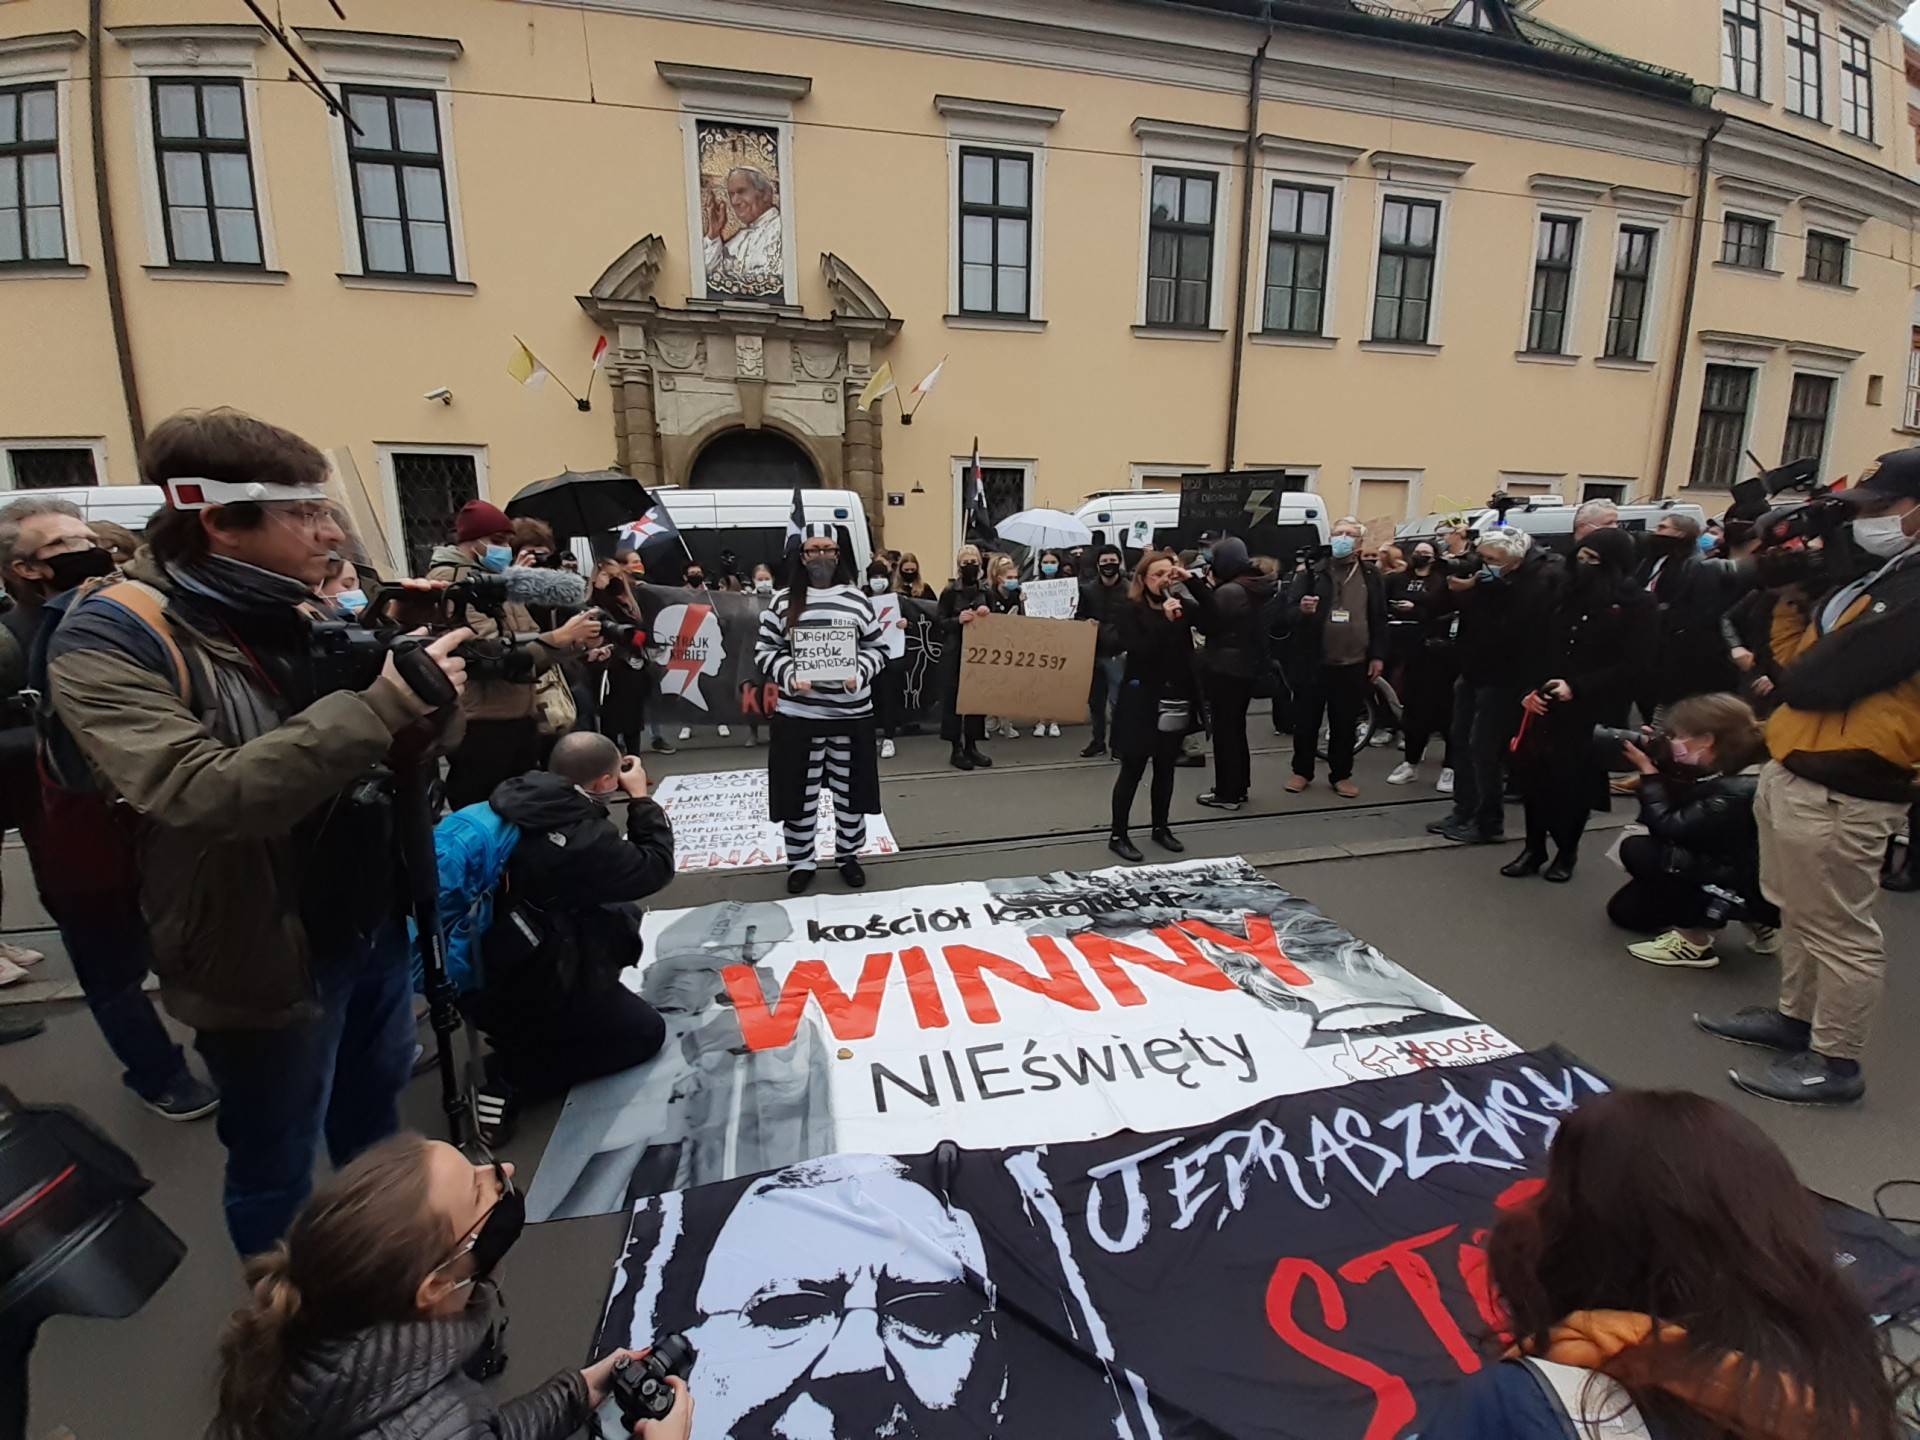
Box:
(48, 409, 470, 1256)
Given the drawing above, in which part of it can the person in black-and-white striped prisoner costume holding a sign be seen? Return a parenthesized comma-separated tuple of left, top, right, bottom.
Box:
(753, 524, 887, 895)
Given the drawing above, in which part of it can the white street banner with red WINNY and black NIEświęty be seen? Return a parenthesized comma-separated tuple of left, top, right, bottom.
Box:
(528, 864, 1515, 1219)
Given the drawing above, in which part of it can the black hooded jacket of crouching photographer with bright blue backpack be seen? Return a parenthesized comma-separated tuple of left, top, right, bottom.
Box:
(480, 770, 674, 1023)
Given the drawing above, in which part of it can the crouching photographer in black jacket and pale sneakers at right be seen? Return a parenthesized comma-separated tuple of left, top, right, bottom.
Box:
(1594, 695, 1780, 970)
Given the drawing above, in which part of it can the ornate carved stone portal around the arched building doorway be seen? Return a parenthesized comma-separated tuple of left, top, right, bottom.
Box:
(580, 234, 900, 540)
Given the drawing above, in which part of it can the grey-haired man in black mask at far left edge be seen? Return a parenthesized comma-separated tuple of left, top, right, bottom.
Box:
(0, 495, 219, 1119)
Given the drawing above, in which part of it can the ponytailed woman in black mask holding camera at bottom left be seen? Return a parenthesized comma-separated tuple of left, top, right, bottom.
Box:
(207, 1135, 693, 1440)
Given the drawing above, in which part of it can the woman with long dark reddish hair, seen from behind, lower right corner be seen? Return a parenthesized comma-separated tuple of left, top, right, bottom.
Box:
(1421, 1091, 1899, 1440)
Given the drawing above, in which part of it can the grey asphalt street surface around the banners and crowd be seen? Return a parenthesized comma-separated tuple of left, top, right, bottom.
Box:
(0, 716, 1920, 1440)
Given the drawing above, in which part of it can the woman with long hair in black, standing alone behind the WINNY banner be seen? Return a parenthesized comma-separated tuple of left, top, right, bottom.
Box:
(1106, 549, 1200, 864)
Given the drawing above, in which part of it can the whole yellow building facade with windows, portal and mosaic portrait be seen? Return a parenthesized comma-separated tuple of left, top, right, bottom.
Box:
(0, 0, 1920, 572)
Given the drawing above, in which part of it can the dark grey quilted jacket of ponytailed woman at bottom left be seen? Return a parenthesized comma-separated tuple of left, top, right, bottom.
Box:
(265, 1315, 588, 1440)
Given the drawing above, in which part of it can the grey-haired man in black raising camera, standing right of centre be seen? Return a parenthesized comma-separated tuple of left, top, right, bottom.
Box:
(1427, 528, 1565, 845)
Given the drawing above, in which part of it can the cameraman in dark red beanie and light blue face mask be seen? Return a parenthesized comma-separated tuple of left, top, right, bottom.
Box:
(426, 499, 599, 810)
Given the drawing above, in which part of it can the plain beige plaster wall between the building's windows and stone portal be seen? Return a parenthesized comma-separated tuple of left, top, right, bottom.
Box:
(0, 0, 1912, 570)
